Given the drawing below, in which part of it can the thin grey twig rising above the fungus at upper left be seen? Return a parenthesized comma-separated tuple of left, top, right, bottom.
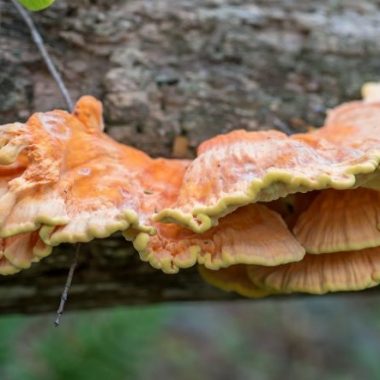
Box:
(11, 0, 74, 111)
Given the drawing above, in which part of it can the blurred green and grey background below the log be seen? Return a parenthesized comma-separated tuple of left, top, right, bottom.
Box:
(0, 295, 380, 380)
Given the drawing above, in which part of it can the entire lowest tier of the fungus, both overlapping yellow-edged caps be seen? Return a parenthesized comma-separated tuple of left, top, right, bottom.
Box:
(200, 247, 380, 298)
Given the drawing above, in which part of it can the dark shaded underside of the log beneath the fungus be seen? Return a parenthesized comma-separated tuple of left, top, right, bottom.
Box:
(0, 236, 380, 314)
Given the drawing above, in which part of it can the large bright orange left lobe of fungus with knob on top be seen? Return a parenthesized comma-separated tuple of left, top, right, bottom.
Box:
(0, 96, 187, 274)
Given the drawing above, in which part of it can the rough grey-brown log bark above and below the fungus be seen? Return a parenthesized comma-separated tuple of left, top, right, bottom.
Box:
(0, 0, 380, 312)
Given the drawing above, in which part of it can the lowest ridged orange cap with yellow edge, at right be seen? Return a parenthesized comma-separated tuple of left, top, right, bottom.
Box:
(247, 247, 380, 294)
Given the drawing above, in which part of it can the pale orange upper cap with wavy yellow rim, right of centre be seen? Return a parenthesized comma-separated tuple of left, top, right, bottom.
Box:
(155, 131, 380, 233)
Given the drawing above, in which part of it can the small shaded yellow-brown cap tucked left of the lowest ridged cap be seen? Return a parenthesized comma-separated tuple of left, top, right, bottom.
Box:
(198, 265, 274, 298)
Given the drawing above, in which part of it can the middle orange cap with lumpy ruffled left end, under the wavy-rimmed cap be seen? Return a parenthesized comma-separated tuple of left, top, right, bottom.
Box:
(134, 204, 305, 273)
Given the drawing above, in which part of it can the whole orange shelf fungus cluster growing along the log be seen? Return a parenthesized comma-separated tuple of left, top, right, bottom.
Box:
(0, 85, 380, 297)
